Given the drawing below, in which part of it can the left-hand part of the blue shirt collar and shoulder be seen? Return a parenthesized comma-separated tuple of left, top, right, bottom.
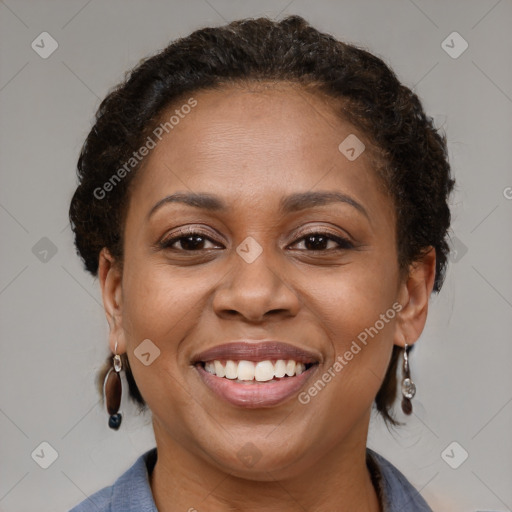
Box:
(69, 448, 157, 512)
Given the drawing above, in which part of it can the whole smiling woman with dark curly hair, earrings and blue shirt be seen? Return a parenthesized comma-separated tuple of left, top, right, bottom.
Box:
(70, 16, 453, 512)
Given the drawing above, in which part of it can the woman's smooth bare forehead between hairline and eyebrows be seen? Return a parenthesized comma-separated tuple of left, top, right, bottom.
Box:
(127, 84, 388, 220)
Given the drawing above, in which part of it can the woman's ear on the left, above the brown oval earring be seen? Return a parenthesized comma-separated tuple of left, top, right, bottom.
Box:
(98, 247, 126, 354)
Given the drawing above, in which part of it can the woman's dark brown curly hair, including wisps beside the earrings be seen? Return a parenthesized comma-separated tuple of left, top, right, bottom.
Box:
(69, 16, 454, 425)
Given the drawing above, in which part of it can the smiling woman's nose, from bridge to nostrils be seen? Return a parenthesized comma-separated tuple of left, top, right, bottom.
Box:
(213, 249, 300, 322)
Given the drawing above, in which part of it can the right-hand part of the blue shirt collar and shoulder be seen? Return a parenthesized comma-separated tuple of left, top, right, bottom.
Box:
(366, 448, 432, 512)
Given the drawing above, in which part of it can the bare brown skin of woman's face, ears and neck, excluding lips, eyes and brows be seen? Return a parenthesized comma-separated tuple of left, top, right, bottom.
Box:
(99, 84, 435, 512)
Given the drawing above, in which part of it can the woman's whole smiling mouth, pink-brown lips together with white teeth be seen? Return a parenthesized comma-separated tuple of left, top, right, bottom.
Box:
(192, 342, 321, 408)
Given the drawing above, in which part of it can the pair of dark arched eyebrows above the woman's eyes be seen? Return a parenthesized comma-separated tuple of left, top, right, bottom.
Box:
(147, 191, 370, 220)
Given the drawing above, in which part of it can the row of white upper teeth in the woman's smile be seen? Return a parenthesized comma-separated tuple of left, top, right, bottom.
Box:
(204, 359, 306, 382)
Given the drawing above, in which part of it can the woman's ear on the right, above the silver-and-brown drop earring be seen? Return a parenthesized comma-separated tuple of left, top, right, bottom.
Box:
(394, 247, 436, 347)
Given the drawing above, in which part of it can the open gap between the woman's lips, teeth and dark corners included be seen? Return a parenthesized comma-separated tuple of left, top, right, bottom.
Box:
(197, 359, 316, 384)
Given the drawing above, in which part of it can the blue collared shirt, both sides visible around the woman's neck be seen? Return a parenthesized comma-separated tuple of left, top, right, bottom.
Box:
(69, 448, 432, 512)
